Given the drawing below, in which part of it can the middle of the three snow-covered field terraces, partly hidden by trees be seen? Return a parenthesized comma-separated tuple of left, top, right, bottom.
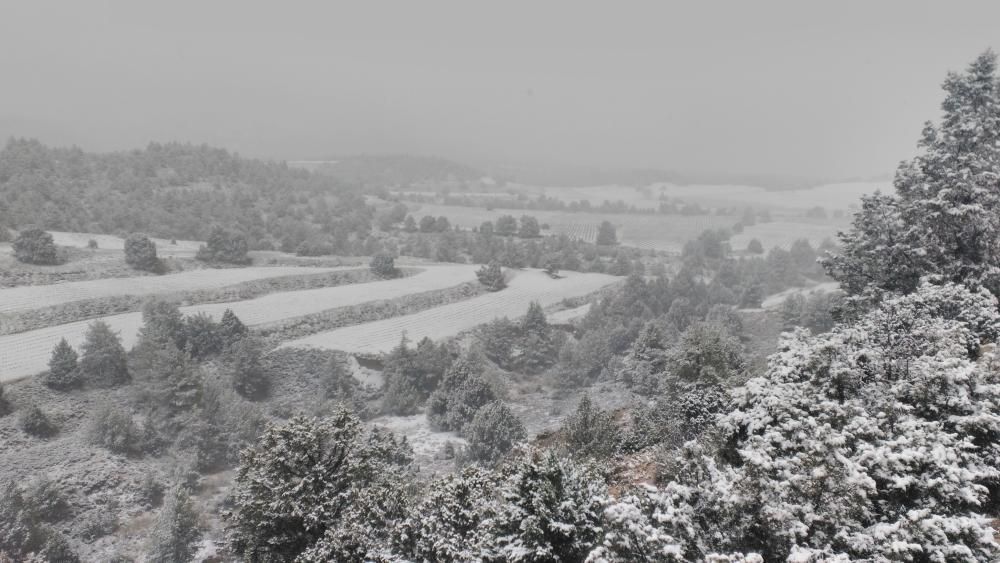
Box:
(0, 264, 476, 381)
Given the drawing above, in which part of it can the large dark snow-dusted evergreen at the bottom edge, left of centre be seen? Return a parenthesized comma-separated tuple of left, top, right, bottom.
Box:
(228, 409, 410, 561)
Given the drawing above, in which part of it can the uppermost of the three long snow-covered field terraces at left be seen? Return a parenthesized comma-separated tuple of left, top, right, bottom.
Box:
(0, 266, 357, 313)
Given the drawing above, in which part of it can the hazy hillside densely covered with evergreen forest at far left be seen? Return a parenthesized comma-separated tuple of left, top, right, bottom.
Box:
(0, 139, 372, 251)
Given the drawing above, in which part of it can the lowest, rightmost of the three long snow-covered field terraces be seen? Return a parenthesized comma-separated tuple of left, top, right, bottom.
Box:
(282, 270, 621, 354)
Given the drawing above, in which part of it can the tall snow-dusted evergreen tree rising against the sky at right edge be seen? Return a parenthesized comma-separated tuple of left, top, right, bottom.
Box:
(824, 51, 1000, 302)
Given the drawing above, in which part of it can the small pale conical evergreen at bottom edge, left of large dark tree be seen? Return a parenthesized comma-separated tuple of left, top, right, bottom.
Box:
(146, 487, 201, 563)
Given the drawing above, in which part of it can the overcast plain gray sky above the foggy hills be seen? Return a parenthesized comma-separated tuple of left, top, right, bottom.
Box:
(0, 0, 1000, 176)
